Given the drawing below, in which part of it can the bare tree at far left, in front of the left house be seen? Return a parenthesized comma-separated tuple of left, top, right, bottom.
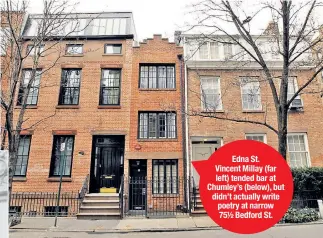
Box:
(1, 0, 99, 199)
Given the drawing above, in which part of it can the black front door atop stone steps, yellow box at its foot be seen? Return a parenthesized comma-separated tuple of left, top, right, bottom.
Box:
(90, 136, 124, 193)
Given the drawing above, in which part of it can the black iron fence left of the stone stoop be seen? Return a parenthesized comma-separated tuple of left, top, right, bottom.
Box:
(9, 192, 82, 217)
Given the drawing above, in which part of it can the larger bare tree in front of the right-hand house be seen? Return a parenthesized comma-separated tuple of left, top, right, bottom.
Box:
(184, 0, 323, 159)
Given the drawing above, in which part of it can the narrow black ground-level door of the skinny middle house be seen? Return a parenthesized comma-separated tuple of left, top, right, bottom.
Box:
(129, 160, 147, 210)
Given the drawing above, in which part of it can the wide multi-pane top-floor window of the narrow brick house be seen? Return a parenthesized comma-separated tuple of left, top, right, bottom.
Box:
(139, 65, 175, 89)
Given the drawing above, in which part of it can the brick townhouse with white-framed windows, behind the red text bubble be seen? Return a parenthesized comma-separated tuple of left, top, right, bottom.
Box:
(181, 25, 323, 213)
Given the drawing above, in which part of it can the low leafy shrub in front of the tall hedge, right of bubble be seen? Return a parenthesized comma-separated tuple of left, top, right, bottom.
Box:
(283, 208, 319, 223)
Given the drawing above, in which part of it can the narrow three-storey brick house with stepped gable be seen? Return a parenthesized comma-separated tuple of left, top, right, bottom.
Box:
(125, 35, 186, 215)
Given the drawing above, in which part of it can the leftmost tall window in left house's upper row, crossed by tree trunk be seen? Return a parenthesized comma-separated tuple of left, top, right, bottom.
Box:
(17, 69, 42, 105)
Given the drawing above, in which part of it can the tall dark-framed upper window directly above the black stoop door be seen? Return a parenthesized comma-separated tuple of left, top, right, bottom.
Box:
(100, 69, 121, 105)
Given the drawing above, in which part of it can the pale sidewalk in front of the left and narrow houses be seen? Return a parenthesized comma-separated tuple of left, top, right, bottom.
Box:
(11, 216, 222, 233)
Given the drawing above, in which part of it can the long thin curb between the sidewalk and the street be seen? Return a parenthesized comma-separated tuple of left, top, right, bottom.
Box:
(10, 220, 323, 234)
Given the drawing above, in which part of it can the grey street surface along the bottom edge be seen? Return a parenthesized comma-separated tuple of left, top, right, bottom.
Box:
(10, 224, 323, 238)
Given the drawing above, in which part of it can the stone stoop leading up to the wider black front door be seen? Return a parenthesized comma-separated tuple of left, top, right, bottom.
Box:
(77, 193, 120, 220)
